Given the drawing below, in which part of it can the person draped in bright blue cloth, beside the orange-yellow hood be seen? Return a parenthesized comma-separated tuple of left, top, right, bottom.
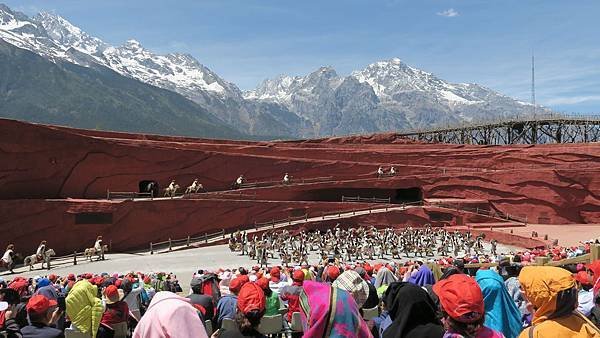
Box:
(475, 270, 523, 338)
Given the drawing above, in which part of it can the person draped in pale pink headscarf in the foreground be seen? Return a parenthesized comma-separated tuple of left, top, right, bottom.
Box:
(133, 291, 208, 338)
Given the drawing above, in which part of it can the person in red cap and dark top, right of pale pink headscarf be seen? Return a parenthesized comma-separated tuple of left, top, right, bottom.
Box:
(213, 283, 266, 338)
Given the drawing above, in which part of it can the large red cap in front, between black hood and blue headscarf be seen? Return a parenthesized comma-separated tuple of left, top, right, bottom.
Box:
(433, 274, 485, 323)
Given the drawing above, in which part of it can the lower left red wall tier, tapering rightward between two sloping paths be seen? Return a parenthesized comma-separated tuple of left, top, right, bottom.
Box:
(0, 199, 380, 255)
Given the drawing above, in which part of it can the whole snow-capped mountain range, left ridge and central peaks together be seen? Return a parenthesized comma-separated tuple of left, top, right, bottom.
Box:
(0, 4, 543, 137)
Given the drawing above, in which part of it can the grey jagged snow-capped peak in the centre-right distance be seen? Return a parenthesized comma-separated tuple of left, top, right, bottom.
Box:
(244, 58, 548, 135)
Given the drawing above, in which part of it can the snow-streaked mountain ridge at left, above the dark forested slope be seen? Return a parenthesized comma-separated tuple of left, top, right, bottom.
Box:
(0, 5, 269, 133)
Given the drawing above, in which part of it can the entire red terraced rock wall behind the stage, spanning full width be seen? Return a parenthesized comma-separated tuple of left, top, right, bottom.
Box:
(0, 120, 600, 253)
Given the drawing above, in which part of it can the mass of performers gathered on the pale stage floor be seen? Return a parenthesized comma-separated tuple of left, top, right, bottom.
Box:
(229, 224, 497, 266)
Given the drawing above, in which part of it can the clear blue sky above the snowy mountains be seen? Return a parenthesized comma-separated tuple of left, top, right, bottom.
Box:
(5, 0, 600, 113)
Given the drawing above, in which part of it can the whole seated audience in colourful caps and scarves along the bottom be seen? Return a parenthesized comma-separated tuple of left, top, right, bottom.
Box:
(0, 251, 600, 338)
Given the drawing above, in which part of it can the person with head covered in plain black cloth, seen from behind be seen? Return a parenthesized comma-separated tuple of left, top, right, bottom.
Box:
(383, 282, 444, 338)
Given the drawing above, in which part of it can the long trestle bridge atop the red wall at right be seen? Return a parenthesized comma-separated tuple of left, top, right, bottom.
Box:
(399, 115, 600, 145)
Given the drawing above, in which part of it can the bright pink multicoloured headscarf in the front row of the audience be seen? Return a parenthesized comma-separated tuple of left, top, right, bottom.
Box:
(300, 281, 372, 338)
